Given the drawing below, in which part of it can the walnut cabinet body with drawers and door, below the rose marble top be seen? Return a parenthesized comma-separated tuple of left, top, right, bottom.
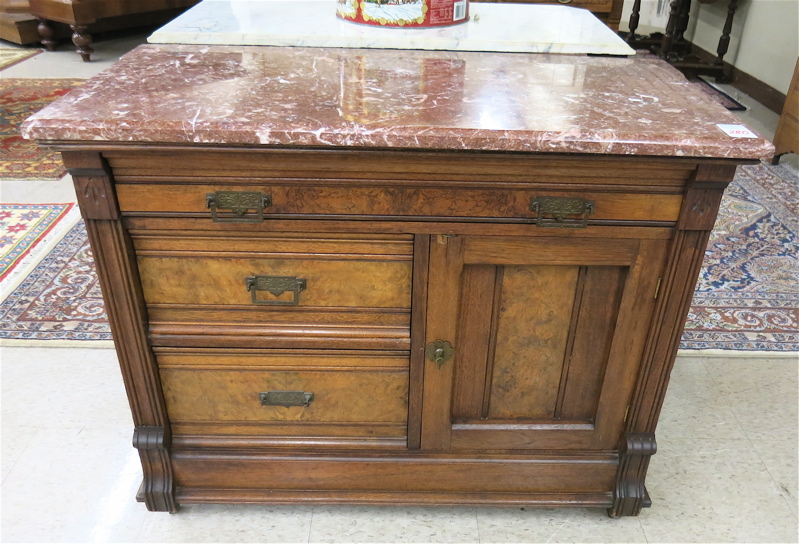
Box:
(62, 147, 743, 516)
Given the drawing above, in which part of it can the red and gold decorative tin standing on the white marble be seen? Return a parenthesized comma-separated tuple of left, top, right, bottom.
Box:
(336, 0, 469, 28)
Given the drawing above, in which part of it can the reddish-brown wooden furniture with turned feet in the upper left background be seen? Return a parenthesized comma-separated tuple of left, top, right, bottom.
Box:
(29, 0, 200, 62)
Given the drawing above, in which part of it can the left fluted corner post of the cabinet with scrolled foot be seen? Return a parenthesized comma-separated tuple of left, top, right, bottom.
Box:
(62, 150, 177, 512)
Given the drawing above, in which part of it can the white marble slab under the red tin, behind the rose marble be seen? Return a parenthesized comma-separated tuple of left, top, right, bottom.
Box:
(148, 0, 635, 55)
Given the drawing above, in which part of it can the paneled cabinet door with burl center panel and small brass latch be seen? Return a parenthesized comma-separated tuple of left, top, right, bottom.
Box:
(421, 233, 667, 450)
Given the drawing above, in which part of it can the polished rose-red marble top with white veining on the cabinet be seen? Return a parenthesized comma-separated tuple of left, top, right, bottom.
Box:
(22, 45, 774, 159)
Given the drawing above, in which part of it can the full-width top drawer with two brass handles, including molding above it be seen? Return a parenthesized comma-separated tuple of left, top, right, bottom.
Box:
(109, 152, 691, 225)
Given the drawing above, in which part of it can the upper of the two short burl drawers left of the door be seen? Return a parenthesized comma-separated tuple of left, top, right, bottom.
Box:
(132, 231, 413, 349)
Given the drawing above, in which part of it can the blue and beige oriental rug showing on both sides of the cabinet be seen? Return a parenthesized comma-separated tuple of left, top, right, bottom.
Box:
(0, 164, 799, 352)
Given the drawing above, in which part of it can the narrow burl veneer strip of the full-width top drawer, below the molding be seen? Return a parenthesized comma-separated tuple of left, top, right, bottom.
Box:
(117, 183, 682, 223)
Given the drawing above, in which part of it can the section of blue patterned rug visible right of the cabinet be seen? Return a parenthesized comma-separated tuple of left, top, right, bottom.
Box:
(681, 164, 799, 351)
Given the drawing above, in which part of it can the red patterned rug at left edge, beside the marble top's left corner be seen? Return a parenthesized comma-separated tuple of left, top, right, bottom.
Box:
(0, 79, 85, 180)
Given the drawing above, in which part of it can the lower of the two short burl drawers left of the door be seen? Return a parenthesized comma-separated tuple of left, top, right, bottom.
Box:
(156, 348, 408, 447)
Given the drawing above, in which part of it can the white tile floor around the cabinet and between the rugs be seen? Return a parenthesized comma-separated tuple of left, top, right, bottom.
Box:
(0, 30, 799, 543)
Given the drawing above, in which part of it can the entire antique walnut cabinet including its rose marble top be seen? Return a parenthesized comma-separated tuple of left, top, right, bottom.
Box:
(24, 45, 772, 516)
